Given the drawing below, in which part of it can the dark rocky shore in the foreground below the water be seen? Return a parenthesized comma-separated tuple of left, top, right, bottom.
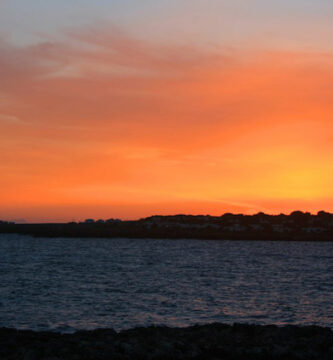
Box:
(0, 323, 333, 360)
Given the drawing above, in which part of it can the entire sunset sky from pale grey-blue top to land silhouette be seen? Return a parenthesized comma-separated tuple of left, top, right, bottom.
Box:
(0, 0, 333, 222)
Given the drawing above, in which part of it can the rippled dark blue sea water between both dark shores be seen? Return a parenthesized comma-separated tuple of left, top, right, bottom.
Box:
(0, 235, 333, 332)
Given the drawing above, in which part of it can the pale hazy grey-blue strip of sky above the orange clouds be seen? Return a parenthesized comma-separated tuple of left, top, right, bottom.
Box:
(0, 0, 333, 50)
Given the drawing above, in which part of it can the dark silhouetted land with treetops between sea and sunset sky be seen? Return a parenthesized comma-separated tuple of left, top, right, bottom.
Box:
(0, 211, 333, 241)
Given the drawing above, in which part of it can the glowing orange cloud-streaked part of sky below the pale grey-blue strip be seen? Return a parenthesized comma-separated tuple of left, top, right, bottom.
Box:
(0, 29, 333, 221)
